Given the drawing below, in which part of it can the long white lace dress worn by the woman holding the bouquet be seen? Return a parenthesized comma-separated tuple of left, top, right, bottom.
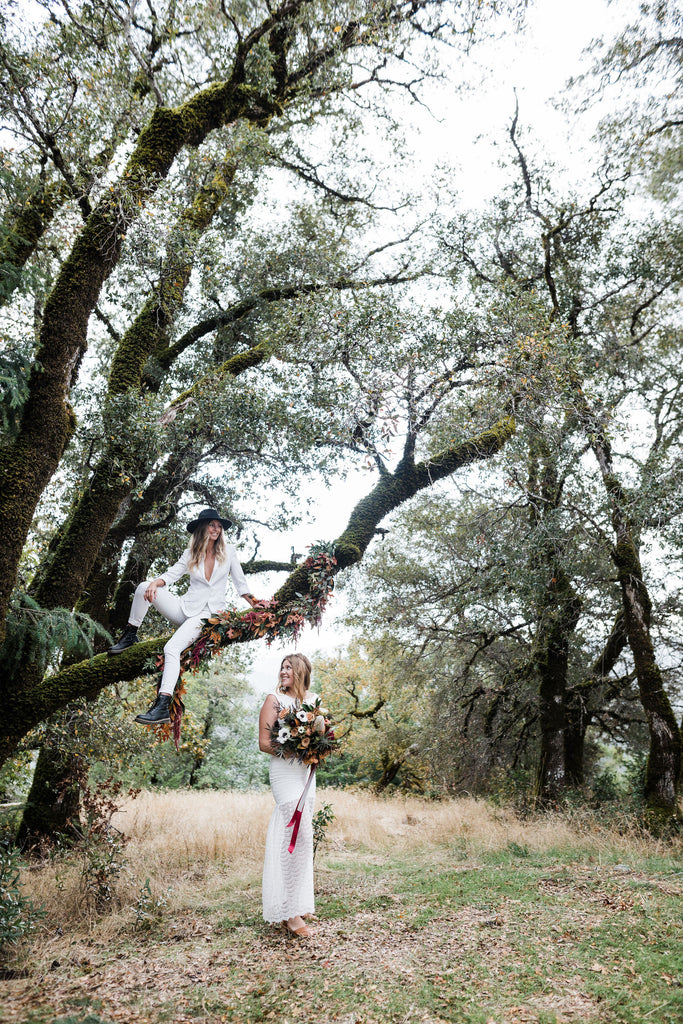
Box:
(263, 693, 315, 925)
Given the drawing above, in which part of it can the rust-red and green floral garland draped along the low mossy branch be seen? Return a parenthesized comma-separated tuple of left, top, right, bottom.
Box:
(151, 542, 338, 750)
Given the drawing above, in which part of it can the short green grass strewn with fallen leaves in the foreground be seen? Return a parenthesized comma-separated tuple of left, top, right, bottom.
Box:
(6, 827, 683, 1024)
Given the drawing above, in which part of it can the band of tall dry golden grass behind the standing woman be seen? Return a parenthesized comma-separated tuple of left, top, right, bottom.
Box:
(18, 790, 683, 934)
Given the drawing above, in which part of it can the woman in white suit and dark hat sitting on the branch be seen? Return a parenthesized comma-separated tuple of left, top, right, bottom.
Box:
(109, 509, 256, 725)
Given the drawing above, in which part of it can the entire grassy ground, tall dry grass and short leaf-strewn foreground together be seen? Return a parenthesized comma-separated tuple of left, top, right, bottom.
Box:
(0, 793, 683, 1024)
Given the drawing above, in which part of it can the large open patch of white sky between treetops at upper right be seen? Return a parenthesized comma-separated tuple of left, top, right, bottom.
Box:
(397, 0, 637, 206)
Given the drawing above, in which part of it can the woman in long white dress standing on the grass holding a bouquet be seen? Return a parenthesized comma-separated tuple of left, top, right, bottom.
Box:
(258, 654, 315, 938)
